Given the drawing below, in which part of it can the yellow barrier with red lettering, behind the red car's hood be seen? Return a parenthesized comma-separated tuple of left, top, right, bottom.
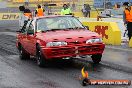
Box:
(82, 21, 121, 45)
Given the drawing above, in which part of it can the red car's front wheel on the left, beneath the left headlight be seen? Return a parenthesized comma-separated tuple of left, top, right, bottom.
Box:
(36, 45, 46, 67)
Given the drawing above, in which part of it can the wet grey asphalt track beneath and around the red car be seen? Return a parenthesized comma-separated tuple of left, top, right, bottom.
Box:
(0, 32, 132, 88)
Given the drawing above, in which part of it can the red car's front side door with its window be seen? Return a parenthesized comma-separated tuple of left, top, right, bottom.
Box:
(27, 23, 36, 55)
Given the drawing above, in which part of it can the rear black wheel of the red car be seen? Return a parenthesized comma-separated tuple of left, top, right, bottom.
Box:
(18, 46, 30, 60)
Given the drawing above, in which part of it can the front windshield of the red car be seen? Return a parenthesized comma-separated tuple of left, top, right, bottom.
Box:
(37, 16, 84, 31)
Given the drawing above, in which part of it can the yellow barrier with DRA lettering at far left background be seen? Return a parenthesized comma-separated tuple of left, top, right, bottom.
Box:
(0, 13, 19, 20)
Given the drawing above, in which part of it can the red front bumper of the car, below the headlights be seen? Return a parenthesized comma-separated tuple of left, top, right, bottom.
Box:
(41, 43, 105, 59)
